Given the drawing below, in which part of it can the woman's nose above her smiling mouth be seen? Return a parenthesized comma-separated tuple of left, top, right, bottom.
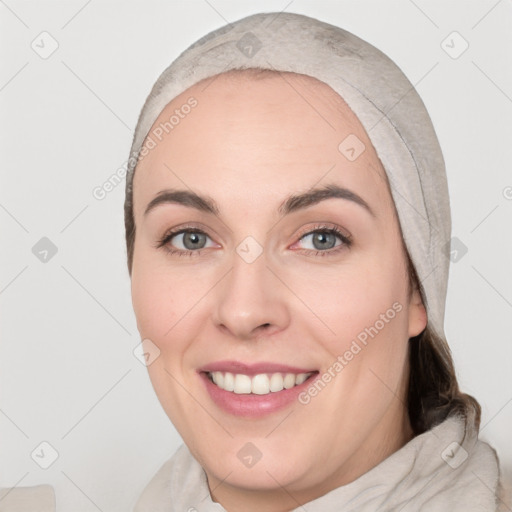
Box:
(213, 247, 290, 340)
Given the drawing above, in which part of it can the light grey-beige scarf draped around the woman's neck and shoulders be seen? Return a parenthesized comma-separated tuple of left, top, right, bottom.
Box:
(134, 415, 500, 512)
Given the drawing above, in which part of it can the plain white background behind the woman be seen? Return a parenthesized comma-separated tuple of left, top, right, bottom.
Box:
(0, 0, 512, 512)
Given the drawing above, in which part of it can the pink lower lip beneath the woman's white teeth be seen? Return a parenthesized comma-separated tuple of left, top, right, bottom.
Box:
(199, 372, 318, 418)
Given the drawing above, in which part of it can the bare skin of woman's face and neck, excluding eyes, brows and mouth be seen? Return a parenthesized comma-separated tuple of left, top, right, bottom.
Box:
(132, 73, 427, 512)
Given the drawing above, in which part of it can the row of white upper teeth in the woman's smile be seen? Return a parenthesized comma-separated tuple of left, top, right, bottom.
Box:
(208, 372, 312, 395)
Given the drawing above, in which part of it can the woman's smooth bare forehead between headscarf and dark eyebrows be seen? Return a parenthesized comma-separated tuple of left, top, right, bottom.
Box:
(134, 72, 390, 216)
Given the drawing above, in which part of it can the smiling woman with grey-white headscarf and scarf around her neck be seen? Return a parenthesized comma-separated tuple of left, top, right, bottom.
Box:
(125, 13, 502, 512)
